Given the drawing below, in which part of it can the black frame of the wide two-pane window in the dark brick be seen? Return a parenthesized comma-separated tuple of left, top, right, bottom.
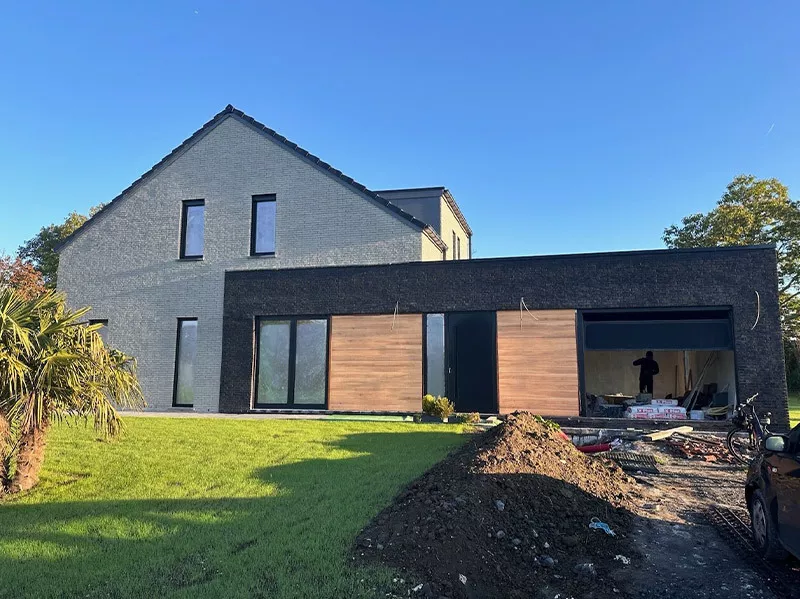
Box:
(250, 314, 331, 410)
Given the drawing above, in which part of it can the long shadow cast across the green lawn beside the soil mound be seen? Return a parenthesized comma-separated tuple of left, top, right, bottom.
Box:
(0, 431, 460, 598)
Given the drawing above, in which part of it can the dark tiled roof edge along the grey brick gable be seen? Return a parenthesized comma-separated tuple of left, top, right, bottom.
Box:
(55, 104, 447, 251)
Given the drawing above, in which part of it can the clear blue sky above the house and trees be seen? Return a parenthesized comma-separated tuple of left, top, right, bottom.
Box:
(0, 0, 800, 257)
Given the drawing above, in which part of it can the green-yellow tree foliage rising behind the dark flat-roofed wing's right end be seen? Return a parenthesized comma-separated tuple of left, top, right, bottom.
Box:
(664, 175, 800, 342)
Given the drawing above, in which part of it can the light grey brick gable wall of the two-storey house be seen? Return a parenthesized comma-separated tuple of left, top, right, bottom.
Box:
(58, 116, 430, 411)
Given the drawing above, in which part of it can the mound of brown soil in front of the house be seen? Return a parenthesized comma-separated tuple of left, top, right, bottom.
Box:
(355, 413, 639, 599)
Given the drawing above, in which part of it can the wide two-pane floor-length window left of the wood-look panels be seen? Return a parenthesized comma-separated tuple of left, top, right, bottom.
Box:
(255, 318, 328, 408)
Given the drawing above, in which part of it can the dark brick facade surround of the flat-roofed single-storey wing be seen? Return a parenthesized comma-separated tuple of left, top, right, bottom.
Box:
(220, 247, 788, 426)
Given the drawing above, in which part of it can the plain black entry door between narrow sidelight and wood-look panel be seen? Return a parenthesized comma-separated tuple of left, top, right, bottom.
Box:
(447, 312, 497, 413)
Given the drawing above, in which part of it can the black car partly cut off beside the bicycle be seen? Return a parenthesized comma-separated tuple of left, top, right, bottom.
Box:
(745, 425, 800, 559)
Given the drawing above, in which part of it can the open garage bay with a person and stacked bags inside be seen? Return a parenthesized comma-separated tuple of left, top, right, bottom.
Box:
(581, 309, 736, 420)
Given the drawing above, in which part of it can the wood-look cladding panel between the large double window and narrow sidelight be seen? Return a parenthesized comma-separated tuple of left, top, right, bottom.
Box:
(328, 314, 422, 412)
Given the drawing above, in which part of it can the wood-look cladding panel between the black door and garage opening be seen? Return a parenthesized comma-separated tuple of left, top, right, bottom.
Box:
(497, 310, 580, 416)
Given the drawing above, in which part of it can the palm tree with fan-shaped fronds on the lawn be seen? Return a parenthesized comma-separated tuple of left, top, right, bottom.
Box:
(0, 288, 144, 494)
